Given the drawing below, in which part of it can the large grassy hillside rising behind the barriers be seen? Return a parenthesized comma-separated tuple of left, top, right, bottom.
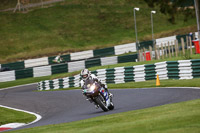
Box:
(0, 0, 196, 64)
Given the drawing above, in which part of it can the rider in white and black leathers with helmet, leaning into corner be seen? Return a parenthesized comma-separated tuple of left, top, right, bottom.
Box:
(81, 69, 113, 108)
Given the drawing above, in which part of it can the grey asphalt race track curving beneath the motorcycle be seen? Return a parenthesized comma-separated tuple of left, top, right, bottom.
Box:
(0, 84, 200, 128)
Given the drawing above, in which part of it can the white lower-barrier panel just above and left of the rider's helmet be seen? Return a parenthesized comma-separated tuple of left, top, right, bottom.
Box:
(68, 60, 85, 72)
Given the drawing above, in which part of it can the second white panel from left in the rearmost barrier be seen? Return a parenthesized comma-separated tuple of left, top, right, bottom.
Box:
(70, 50, 94, 60)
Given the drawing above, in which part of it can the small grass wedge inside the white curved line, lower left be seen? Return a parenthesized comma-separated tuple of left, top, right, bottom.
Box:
(0, 107, 36, 125)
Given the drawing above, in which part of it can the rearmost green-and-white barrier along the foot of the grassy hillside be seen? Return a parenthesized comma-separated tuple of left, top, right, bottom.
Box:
(0, 32, 194, 70)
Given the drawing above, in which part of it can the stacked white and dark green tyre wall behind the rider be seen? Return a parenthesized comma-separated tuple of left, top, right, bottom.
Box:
(38, 59, 200, 90)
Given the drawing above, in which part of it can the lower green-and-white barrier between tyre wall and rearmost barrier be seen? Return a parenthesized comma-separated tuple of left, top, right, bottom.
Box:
(0, 54, 137, 82)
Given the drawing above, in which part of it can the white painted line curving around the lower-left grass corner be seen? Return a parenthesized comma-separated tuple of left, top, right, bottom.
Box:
(0, 105, 42, 127)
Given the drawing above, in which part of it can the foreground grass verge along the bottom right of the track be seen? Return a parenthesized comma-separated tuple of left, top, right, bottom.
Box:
(7, 99, 200, 133)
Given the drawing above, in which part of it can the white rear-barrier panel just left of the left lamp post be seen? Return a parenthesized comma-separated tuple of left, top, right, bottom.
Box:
(114, 43, 136, 55)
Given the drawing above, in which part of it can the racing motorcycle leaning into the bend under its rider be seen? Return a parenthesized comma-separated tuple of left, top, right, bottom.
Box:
(83, 79, 114, 112)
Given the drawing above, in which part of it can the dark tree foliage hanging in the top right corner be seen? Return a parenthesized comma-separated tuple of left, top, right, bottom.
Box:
(144, 0, 194, 24)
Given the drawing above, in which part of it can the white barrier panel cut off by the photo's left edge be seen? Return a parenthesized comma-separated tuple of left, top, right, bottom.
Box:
(0, 71, 16, 82)
